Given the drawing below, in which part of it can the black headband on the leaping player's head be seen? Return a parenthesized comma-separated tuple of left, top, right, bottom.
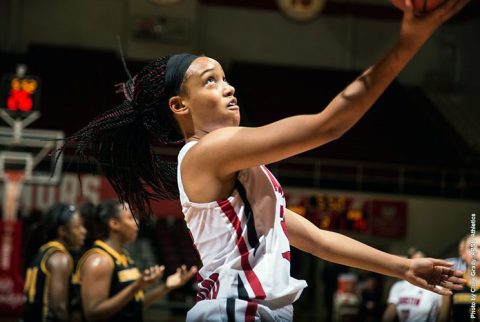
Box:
(165, 53, 199, 97)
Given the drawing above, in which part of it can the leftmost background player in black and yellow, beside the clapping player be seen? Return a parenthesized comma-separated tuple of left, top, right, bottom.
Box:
(23, 204, 86, 322)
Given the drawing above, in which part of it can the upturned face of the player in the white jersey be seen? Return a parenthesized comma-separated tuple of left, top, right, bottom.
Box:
(181, 57, 240, 132)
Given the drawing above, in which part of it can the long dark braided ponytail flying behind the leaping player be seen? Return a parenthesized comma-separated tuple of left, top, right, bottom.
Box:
(67, 56, 191, 215)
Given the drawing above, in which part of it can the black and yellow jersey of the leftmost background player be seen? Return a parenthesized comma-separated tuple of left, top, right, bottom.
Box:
(23, 241, 73, 322)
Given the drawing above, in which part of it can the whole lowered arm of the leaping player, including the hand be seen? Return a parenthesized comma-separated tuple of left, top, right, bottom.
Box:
(285, 209, 465, 295)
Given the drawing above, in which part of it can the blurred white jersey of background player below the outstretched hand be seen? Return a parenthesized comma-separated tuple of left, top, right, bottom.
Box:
(387, 281, 442, 322)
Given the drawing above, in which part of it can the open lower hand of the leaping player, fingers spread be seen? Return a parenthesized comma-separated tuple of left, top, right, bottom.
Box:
(405, 258, 467, 295)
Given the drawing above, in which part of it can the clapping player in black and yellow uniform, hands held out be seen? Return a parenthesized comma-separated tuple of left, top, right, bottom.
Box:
(75, 200, 197, 322)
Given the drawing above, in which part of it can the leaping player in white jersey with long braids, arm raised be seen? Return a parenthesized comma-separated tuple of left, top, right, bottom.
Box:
(67, 0, 468, 321)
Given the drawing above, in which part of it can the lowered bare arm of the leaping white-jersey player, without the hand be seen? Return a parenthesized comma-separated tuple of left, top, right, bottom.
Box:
(285, 211, 409, 278)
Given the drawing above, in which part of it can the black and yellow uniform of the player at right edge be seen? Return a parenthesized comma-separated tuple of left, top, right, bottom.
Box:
(451, 275, 480, 322)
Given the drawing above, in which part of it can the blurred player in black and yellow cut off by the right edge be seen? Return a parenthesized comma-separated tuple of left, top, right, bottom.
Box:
(438, 234, 480, 322)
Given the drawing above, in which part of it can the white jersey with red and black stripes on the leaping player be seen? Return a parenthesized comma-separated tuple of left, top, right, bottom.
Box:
(178, 141, 307, 310)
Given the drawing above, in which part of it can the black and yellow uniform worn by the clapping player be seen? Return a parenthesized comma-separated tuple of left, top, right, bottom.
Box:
(74, 240, 144, 322)
